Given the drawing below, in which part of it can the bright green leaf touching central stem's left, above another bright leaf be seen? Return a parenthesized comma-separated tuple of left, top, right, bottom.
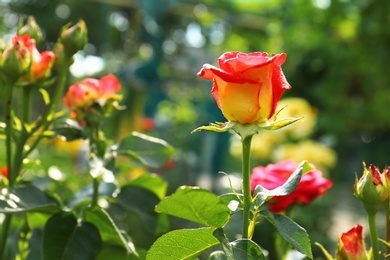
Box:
(156, 186, 231, 229)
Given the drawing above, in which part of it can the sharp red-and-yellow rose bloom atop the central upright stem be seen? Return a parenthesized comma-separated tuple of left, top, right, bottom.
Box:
(198, 52, 291, 124)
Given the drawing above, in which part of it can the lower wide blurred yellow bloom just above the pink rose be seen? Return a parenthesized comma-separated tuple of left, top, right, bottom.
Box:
(273, 140, 337, 174)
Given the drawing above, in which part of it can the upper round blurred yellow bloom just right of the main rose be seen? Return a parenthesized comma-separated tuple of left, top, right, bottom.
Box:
(277, 97, 317, 139)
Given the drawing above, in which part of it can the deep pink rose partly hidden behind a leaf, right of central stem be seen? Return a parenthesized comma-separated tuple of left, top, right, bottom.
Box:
(251, 160, 333, 212)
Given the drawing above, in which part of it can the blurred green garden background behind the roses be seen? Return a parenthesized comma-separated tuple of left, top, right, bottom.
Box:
(0, 0, 390, 255)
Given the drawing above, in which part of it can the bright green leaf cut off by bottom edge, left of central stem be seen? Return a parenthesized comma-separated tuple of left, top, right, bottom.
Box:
(146, 228, 219, 260)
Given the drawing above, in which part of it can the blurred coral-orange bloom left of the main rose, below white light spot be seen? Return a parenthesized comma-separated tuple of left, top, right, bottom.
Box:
(63, 74, 121, 125)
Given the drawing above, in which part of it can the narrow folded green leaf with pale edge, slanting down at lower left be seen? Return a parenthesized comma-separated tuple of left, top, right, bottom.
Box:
(83, 207, 136, 254)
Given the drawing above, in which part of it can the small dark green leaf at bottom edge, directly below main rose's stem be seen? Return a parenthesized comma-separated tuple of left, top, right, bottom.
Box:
(230, 239, 266, 260)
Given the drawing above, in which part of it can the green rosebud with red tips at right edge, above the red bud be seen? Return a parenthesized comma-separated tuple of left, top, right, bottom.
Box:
(354, 162, 390, 211)
